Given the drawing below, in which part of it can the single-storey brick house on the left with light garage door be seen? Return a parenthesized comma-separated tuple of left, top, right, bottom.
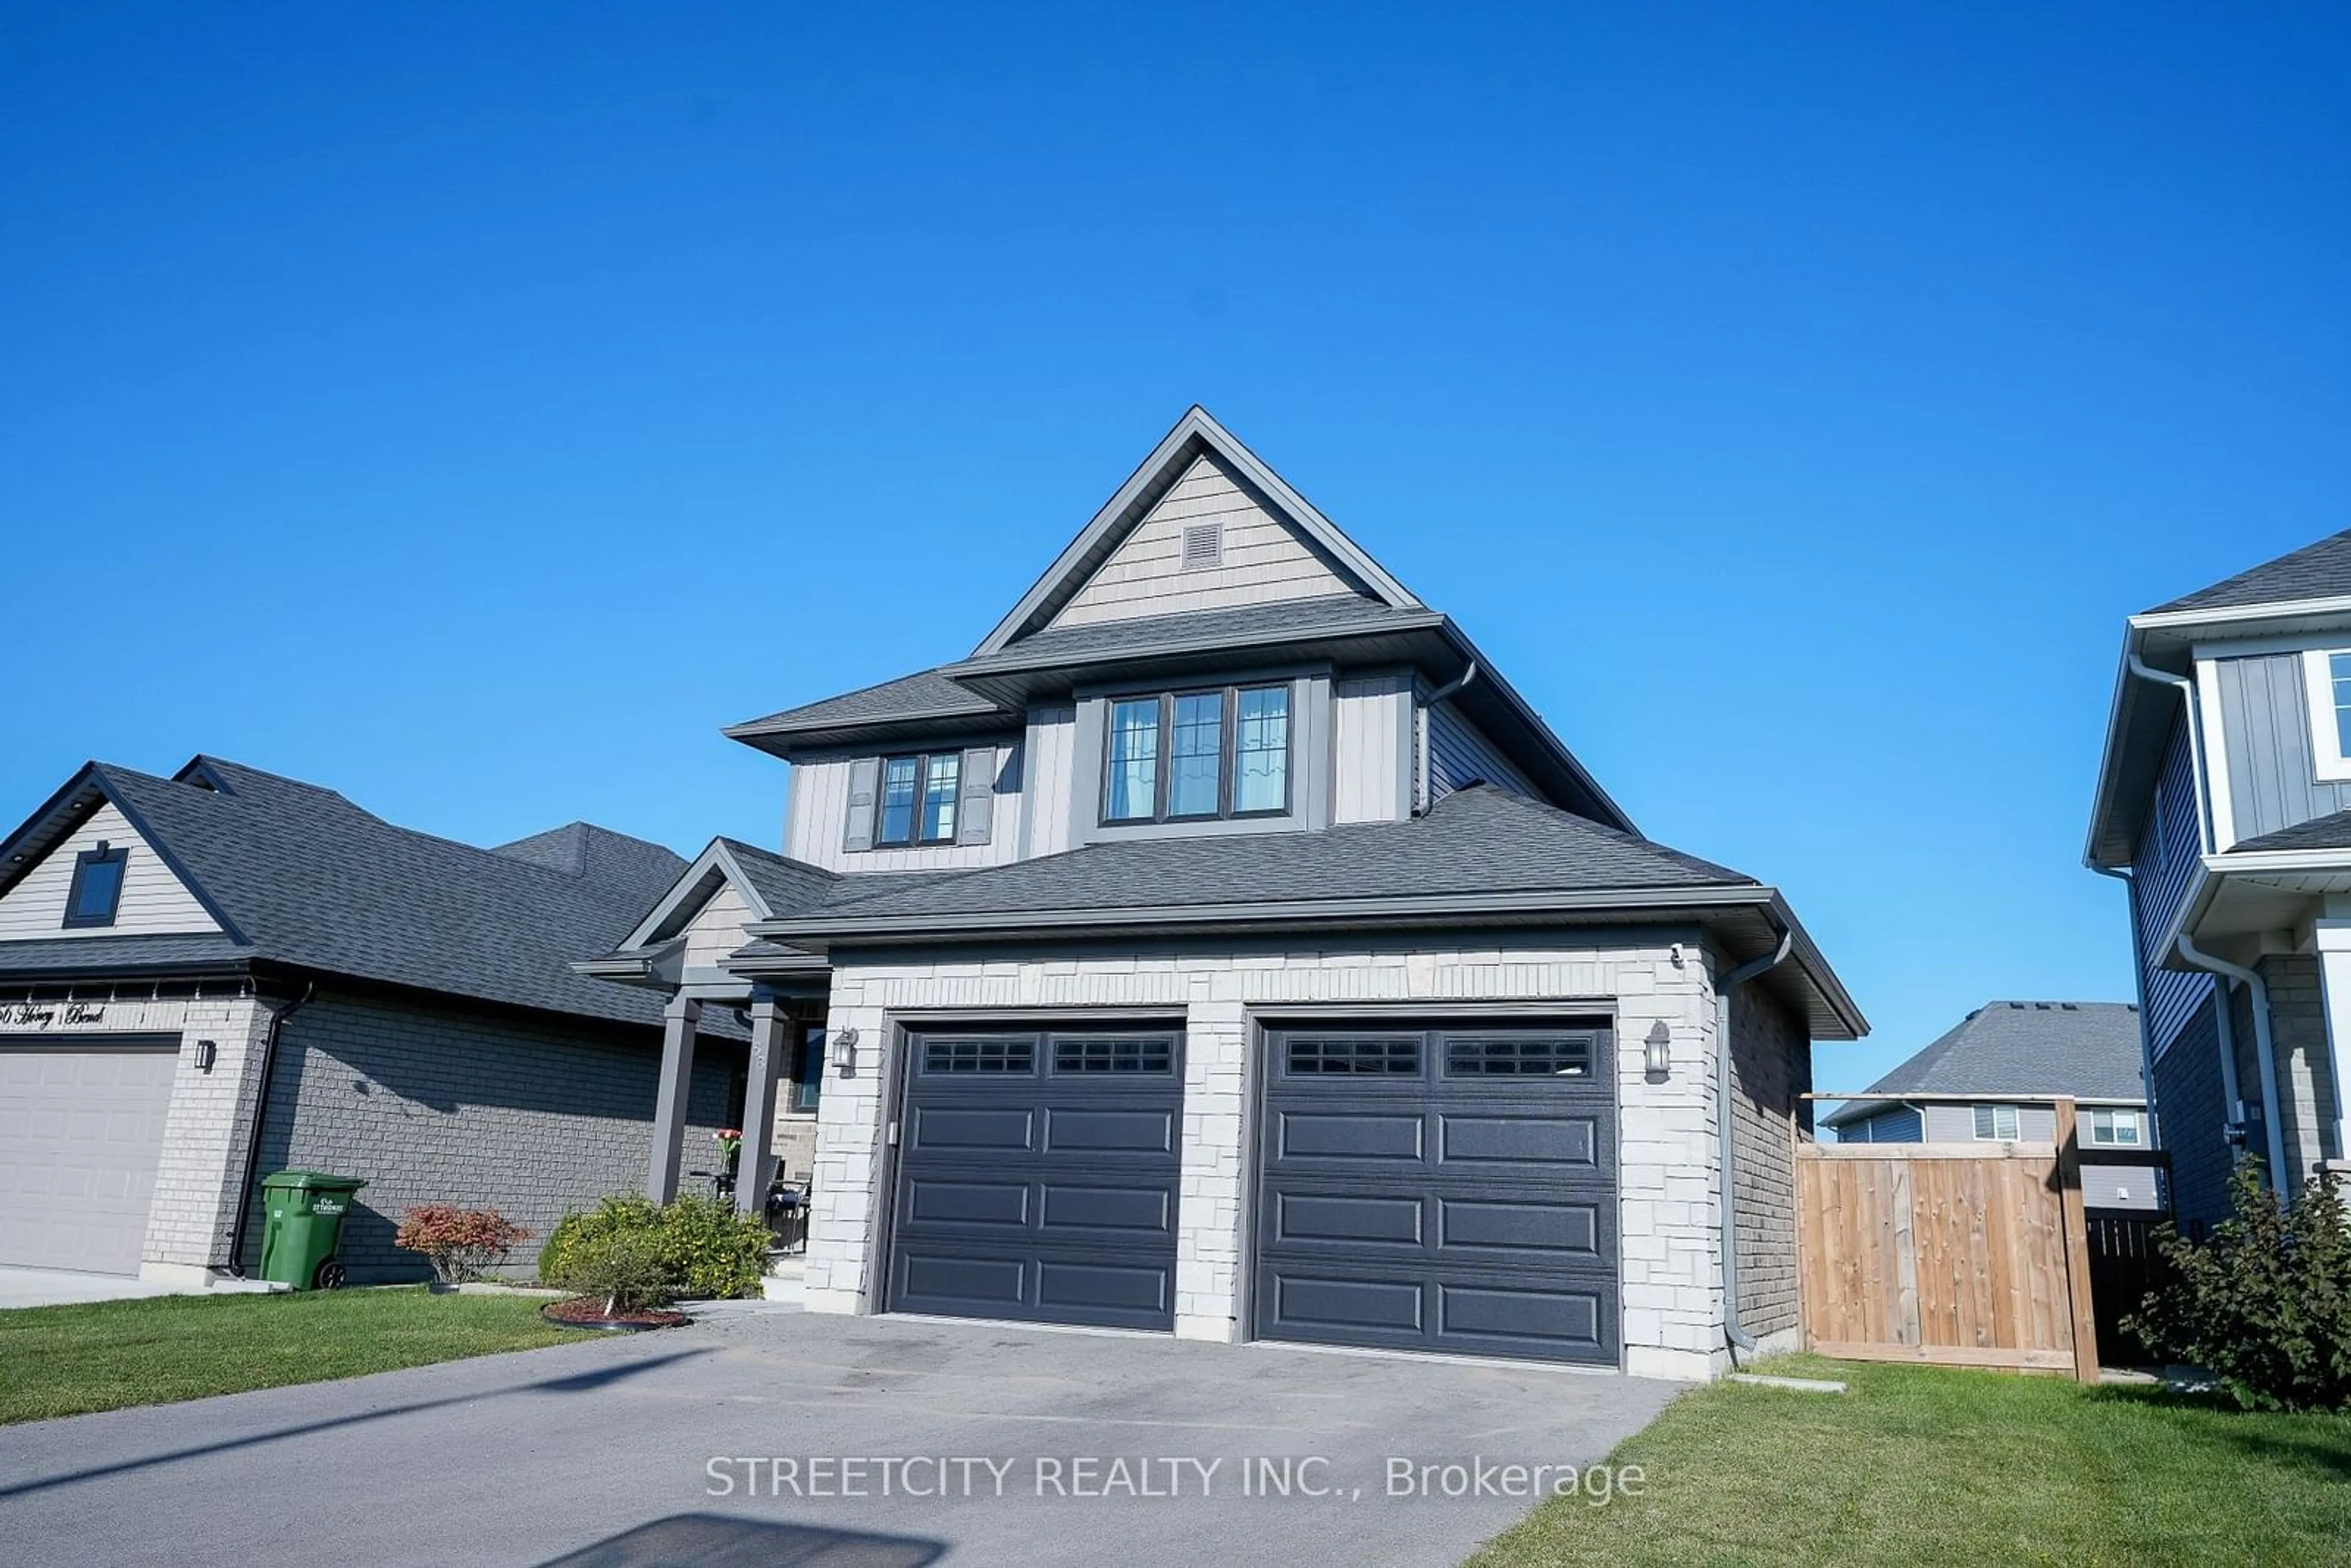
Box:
(0, 757, 743, 1283)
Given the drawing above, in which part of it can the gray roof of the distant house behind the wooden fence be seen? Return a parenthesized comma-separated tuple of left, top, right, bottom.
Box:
(1827, 1002, 2147, 1126)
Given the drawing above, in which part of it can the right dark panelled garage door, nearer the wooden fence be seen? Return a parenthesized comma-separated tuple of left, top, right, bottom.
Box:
(1256, 1022, 1618, 1366)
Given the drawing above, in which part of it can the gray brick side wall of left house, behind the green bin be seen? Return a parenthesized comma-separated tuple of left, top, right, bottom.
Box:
(244, 992, 743, 1281)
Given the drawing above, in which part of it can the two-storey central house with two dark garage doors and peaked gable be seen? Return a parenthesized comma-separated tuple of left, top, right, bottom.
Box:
(580, 409, 1864, 1378)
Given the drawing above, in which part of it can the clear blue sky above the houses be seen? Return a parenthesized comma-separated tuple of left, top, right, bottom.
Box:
(0, 2, 2351, 1089)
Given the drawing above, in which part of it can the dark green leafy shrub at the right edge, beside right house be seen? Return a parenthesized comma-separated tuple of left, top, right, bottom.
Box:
(2123, 1159, 2351, 1411)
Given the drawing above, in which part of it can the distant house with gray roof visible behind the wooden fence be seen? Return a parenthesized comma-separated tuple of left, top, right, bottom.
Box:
(1822, 1002, 2163, 1213)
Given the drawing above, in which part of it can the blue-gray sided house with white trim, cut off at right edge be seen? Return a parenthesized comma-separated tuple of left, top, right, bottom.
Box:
(2085, 531, 2351, 1223)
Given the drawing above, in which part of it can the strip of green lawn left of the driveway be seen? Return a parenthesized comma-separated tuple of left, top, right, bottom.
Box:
(0, 1286, 576, 1425)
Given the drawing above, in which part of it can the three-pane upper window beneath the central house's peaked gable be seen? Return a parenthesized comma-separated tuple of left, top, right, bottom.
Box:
(1103, 684, 1291, 823)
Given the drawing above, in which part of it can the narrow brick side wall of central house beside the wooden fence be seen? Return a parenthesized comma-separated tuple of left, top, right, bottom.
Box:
(1730, 980, 1813, 1335)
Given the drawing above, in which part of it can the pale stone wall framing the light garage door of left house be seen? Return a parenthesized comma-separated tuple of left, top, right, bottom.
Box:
(0, 988, 272, 1283)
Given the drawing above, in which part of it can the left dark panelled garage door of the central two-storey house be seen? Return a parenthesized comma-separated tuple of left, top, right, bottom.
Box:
(889, 1030, 1183, 1328)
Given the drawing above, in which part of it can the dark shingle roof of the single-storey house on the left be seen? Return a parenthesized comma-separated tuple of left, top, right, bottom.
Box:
(0, 757, 686, 1022)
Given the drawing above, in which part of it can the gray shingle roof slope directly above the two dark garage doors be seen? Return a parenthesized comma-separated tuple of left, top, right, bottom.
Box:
(785, 785, 1754, 917)
